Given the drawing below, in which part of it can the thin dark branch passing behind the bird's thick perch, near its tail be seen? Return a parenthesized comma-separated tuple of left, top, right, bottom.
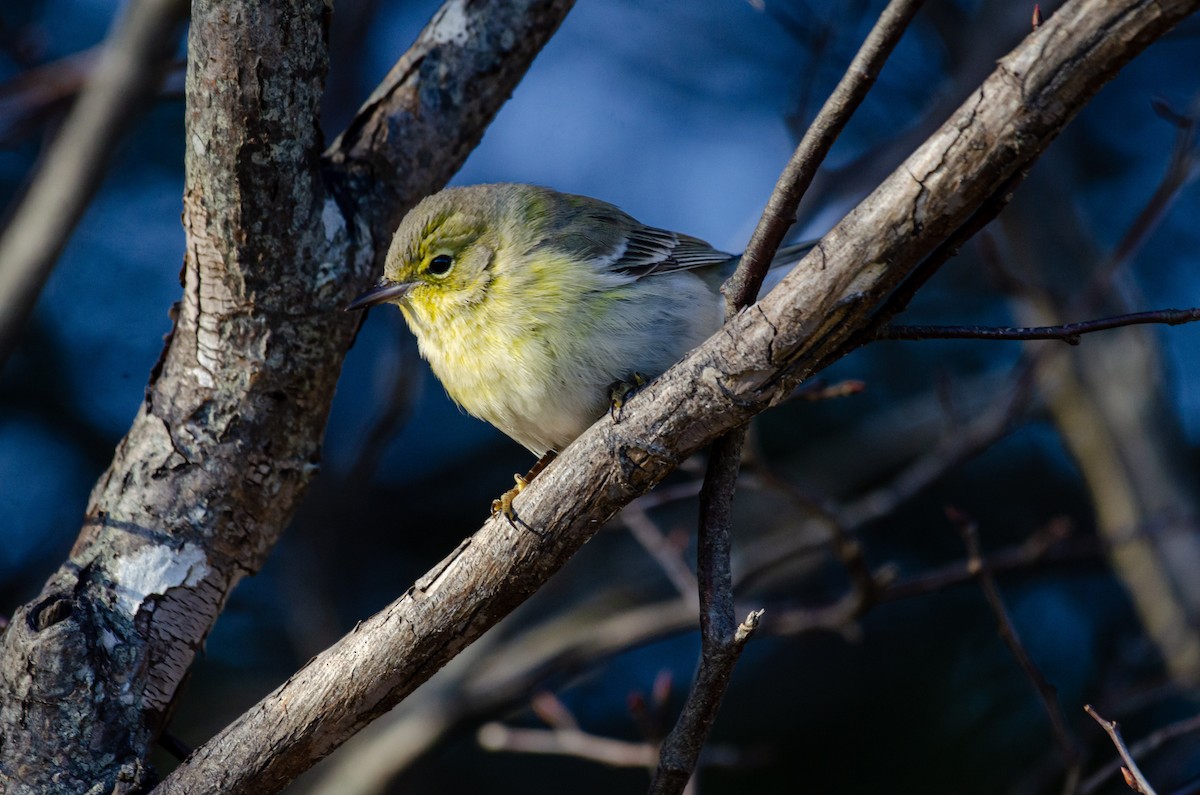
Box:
(649, 0, 923, 793)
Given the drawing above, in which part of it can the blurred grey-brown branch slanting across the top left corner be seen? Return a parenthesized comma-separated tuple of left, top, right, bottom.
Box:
(0, 0, 188, 369)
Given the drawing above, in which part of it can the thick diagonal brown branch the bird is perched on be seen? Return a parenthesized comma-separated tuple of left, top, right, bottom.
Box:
(150, 0, 1200, 793)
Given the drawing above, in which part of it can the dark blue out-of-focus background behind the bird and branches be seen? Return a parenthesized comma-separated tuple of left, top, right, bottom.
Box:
(0, 0, 1200, 793)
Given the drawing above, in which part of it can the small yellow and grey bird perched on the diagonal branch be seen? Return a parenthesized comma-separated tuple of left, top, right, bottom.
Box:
(350, 184, 808, 512)
